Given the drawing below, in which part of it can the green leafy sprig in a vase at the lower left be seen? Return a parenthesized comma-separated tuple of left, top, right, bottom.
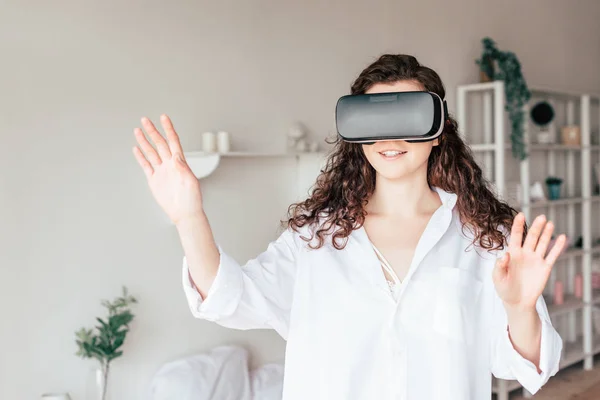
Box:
(75, 287, 137, 400)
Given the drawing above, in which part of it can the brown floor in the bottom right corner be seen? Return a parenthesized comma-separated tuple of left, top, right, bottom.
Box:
(510, 357, 600, 400)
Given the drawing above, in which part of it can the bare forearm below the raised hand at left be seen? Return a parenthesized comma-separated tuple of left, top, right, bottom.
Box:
(176, 213, 220, 298)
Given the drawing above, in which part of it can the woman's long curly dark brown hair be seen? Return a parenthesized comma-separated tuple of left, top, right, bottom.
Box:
(287, 54, 517, 250)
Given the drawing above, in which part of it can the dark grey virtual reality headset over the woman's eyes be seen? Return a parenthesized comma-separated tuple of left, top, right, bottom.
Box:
(335, 92, 448, 144)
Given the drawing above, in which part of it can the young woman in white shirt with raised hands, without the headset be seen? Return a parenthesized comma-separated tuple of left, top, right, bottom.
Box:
(134, 55, 565, 400)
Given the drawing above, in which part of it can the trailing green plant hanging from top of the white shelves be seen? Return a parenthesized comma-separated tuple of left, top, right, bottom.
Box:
(475, 37, 531, 160)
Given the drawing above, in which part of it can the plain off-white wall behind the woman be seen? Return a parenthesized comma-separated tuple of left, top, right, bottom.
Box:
(0, 0, 600, 400)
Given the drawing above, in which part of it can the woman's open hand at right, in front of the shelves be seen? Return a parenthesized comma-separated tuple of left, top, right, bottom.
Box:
(493, 213, 566, 309)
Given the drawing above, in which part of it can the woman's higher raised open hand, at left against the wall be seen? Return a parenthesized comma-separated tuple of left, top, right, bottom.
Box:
(133, 114, 204, 225)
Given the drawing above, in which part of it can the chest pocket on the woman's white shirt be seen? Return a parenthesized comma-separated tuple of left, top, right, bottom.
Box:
(401, 267, 482, 344)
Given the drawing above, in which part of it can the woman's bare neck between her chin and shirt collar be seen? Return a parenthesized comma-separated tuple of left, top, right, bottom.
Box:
(366, 174, 442, 218)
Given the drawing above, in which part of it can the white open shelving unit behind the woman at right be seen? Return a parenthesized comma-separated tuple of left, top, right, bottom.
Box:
(457, 81, 600, 400)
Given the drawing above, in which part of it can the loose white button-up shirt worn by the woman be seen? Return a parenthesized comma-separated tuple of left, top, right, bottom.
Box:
(183, 189, 562, 400)
